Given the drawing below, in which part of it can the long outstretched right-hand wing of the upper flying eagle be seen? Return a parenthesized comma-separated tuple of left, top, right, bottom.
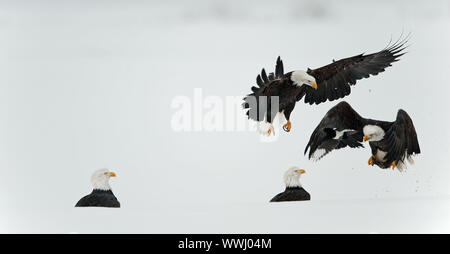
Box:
(304, 38, 408, 104)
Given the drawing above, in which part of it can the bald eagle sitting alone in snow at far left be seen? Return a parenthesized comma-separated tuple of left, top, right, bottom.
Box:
(75, 169, 120, 207)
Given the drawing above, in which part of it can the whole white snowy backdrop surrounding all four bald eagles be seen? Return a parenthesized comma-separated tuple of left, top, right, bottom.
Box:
(0, 0, 450, 233)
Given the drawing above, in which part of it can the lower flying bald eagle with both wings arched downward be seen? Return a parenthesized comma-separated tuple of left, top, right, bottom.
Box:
(305, 101, 420, 171)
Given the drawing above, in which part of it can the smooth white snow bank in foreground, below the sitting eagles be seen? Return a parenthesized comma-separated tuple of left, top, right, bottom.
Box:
(1, 198, 450, 234)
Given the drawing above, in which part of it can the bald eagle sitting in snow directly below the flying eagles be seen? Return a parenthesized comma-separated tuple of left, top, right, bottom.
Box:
(270, 167, 311, 202)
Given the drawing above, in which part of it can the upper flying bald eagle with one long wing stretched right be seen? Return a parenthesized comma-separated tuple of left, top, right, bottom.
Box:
(243, 37, 408, 135)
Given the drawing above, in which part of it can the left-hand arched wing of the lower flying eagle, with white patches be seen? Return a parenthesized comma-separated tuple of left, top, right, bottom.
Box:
(305, 101, 366, 160)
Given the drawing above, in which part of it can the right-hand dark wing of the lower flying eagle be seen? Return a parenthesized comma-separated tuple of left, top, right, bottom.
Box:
(378, 109, 420, 165)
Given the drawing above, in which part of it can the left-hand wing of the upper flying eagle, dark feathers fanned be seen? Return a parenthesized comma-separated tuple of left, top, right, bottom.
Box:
(242, 57, 303, 122)
